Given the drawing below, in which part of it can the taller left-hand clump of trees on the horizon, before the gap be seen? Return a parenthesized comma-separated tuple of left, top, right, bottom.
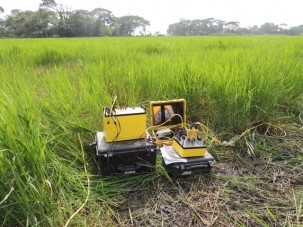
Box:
(0, 0, 150, 37)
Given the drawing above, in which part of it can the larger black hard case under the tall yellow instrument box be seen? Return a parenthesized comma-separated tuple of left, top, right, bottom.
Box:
(94, 132, 158, 175)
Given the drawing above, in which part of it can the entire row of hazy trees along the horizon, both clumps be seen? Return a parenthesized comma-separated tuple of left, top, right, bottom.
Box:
(0, 0, 303, 37)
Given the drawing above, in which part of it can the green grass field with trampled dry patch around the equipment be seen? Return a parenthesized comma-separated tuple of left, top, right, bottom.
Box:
(0, 36, 303, 226)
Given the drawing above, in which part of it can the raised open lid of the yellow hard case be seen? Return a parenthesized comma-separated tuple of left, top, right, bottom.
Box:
(150, 99, 186, 128)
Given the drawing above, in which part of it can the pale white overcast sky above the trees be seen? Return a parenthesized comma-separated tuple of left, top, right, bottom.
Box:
(0, 0, 303, 33)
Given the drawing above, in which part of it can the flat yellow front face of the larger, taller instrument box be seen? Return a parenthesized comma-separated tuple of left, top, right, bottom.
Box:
(103, 113, 146, 143)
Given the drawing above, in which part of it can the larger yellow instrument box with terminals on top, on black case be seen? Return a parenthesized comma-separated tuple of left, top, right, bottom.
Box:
(103, 107, 146, 143)
